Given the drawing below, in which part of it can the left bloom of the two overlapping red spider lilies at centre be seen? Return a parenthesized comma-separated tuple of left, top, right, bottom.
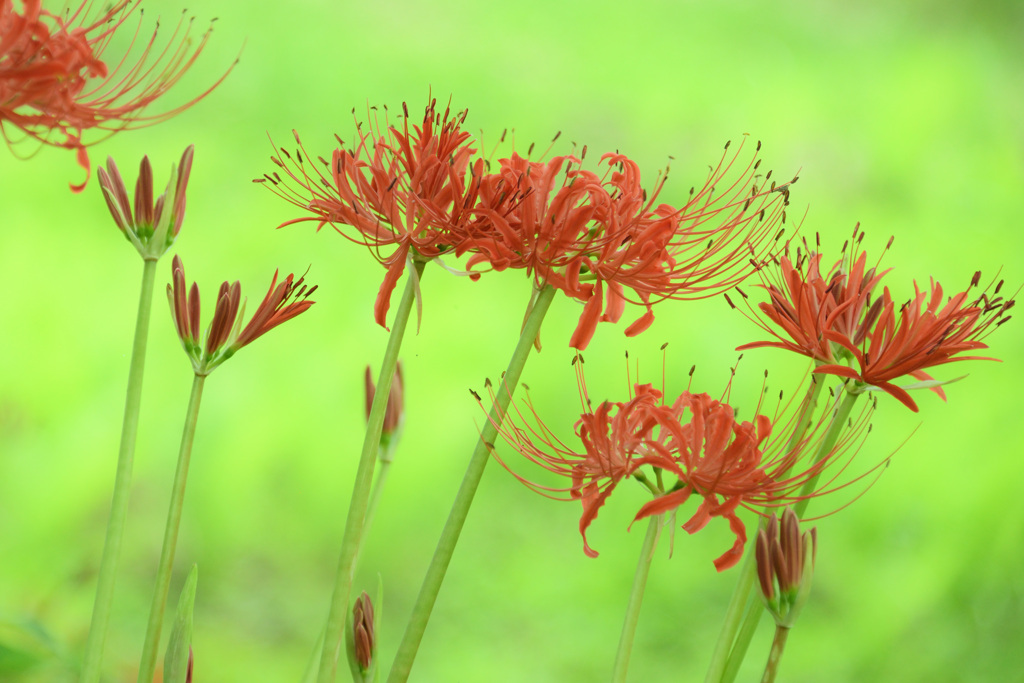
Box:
(256, 99, 483, 328)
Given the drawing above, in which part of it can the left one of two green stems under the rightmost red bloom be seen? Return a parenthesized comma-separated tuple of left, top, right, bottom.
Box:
(705, 374, 824, 683)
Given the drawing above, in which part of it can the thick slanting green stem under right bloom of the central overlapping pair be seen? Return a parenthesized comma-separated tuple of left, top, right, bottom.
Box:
(385, 286, 555, 683)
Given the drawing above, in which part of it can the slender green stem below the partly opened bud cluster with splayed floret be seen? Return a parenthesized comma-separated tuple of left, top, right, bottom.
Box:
(138, 375, 206, 683)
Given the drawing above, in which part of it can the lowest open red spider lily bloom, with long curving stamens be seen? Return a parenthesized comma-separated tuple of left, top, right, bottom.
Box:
(479, 356, 871, 571)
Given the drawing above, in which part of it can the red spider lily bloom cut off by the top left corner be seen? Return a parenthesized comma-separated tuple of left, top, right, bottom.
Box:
(0, 0, 230, 191)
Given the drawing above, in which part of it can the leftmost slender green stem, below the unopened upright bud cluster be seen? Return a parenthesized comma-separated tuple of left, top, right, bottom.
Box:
(81, 261, 157, 683)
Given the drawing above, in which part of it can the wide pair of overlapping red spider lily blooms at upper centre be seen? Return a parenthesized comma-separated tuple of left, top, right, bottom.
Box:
(257, 100, 796, 349)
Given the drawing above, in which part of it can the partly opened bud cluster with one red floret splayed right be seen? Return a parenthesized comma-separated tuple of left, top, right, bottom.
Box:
(167, 256, 316, 376)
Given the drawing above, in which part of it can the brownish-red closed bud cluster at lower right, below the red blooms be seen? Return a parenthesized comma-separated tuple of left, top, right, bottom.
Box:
(756, 508, 817, 629)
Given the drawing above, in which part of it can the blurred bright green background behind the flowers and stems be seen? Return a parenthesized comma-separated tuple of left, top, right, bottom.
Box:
(0, 0, 1024, 682)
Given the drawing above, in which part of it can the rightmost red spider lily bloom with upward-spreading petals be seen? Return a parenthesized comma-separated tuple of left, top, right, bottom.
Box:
(737, 226, 1014, 412)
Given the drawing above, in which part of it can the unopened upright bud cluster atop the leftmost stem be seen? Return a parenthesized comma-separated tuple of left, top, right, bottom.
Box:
(98, 144, 195, 261)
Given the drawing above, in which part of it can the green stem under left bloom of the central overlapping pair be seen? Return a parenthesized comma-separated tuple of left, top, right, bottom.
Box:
(316, 260, 425, 683)
